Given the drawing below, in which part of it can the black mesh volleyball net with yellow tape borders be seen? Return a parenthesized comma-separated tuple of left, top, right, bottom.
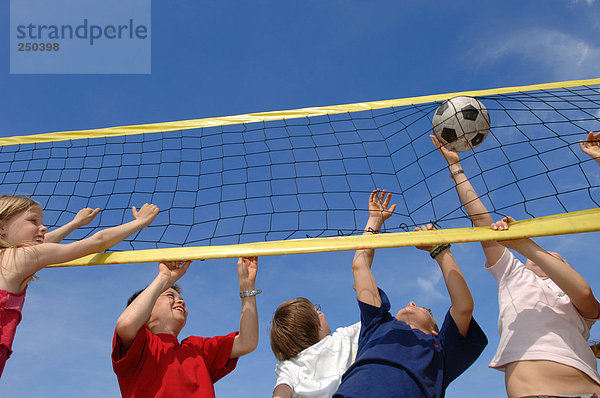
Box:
(0, 79, 600, 265)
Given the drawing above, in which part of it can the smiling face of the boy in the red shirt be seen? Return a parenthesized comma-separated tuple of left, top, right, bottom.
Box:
(146, 288, 188, 336)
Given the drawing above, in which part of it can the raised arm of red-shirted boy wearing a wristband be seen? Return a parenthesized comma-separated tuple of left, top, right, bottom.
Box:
(229, 257, 258, 358)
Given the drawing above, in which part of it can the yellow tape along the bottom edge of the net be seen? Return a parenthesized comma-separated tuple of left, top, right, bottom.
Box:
(52, 208, 600, 267)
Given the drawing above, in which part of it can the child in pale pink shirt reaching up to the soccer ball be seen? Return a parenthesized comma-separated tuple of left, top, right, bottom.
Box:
(430, 135, 600, 397)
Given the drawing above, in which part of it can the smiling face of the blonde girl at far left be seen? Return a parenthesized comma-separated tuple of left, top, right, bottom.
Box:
(0, 206, 48, 245)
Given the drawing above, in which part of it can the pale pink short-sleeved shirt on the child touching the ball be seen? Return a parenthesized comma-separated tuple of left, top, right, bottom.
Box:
(485, 250, 600, 383)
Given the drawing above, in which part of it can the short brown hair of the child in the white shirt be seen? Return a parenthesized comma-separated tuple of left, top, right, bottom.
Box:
(271, 297, 320, 361)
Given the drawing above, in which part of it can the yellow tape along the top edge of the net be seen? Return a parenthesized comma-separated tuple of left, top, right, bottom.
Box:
(0, 78, 600, 146)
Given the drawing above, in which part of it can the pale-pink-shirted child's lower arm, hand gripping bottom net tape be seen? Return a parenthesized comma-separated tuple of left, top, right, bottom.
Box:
(492, 217, 600, 319)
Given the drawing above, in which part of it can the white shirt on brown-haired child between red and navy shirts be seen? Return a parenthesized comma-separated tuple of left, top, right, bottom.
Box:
(275, 322, 360, 398)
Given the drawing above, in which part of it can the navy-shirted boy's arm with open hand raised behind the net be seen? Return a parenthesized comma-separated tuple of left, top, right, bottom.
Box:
(352, 189, 396, 307)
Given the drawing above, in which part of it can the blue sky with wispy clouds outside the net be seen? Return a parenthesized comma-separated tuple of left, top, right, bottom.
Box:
(0, 0, 600, 397)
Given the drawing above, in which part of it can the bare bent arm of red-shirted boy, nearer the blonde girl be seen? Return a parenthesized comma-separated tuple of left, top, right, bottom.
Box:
(116, 261, 192, 351)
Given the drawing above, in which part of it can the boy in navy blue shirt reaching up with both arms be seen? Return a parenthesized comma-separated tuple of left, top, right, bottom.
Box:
(334, 189, 487, 398)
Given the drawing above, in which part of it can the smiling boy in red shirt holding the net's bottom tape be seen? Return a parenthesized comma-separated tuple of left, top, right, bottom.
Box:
(112, 257, 260, 398)
